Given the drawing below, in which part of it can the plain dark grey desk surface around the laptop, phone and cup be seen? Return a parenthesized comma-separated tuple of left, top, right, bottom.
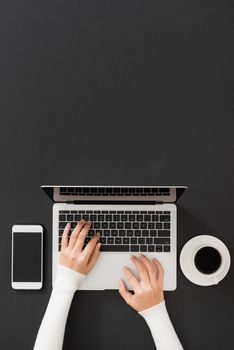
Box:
(0, 0, 234, 350)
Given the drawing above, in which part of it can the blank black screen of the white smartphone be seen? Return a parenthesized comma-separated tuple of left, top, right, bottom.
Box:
(13, 232, 42, 282)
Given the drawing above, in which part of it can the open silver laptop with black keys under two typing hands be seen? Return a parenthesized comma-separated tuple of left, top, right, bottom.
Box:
(41, 185, 187, 291)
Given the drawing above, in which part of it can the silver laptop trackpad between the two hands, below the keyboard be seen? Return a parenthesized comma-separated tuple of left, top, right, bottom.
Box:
(87, 253, 137, 289)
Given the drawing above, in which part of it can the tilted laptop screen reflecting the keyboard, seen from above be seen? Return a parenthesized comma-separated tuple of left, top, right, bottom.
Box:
(41, 185, 187, 203)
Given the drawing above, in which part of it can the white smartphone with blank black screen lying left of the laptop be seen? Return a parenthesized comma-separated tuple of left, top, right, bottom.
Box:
(11, 225, 43, 289)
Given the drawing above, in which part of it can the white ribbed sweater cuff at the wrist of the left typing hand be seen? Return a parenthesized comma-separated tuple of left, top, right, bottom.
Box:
(54, 264, 86, 292)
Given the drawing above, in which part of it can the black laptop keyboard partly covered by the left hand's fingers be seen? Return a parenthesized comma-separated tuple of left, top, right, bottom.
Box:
(58, 210, 171, 253)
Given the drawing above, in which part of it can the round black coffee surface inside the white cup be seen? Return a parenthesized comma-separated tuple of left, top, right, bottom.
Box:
(194, 247, 222, 274)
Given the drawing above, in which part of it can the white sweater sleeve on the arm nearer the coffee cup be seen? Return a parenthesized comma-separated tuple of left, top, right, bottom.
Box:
(139, 301, 183, 350)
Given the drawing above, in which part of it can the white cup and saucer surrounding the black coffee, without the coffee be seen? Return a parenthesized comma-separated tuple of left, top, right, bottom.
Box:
(180, 235, 231, 286)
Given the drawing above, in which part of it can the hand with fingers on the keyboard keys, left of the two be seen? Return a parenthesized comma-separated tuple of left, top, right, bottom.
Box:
(59, 220, 101, 275)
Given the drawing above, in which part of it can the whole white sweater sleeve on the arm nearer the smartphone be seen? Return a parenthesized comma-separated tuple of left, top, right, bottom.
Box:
(33, 264, 85, 350)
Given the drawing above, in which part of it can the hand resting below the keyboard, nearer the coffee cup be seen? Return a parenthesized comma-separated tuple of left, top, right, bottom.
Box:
(119, 254, 164, 312)
